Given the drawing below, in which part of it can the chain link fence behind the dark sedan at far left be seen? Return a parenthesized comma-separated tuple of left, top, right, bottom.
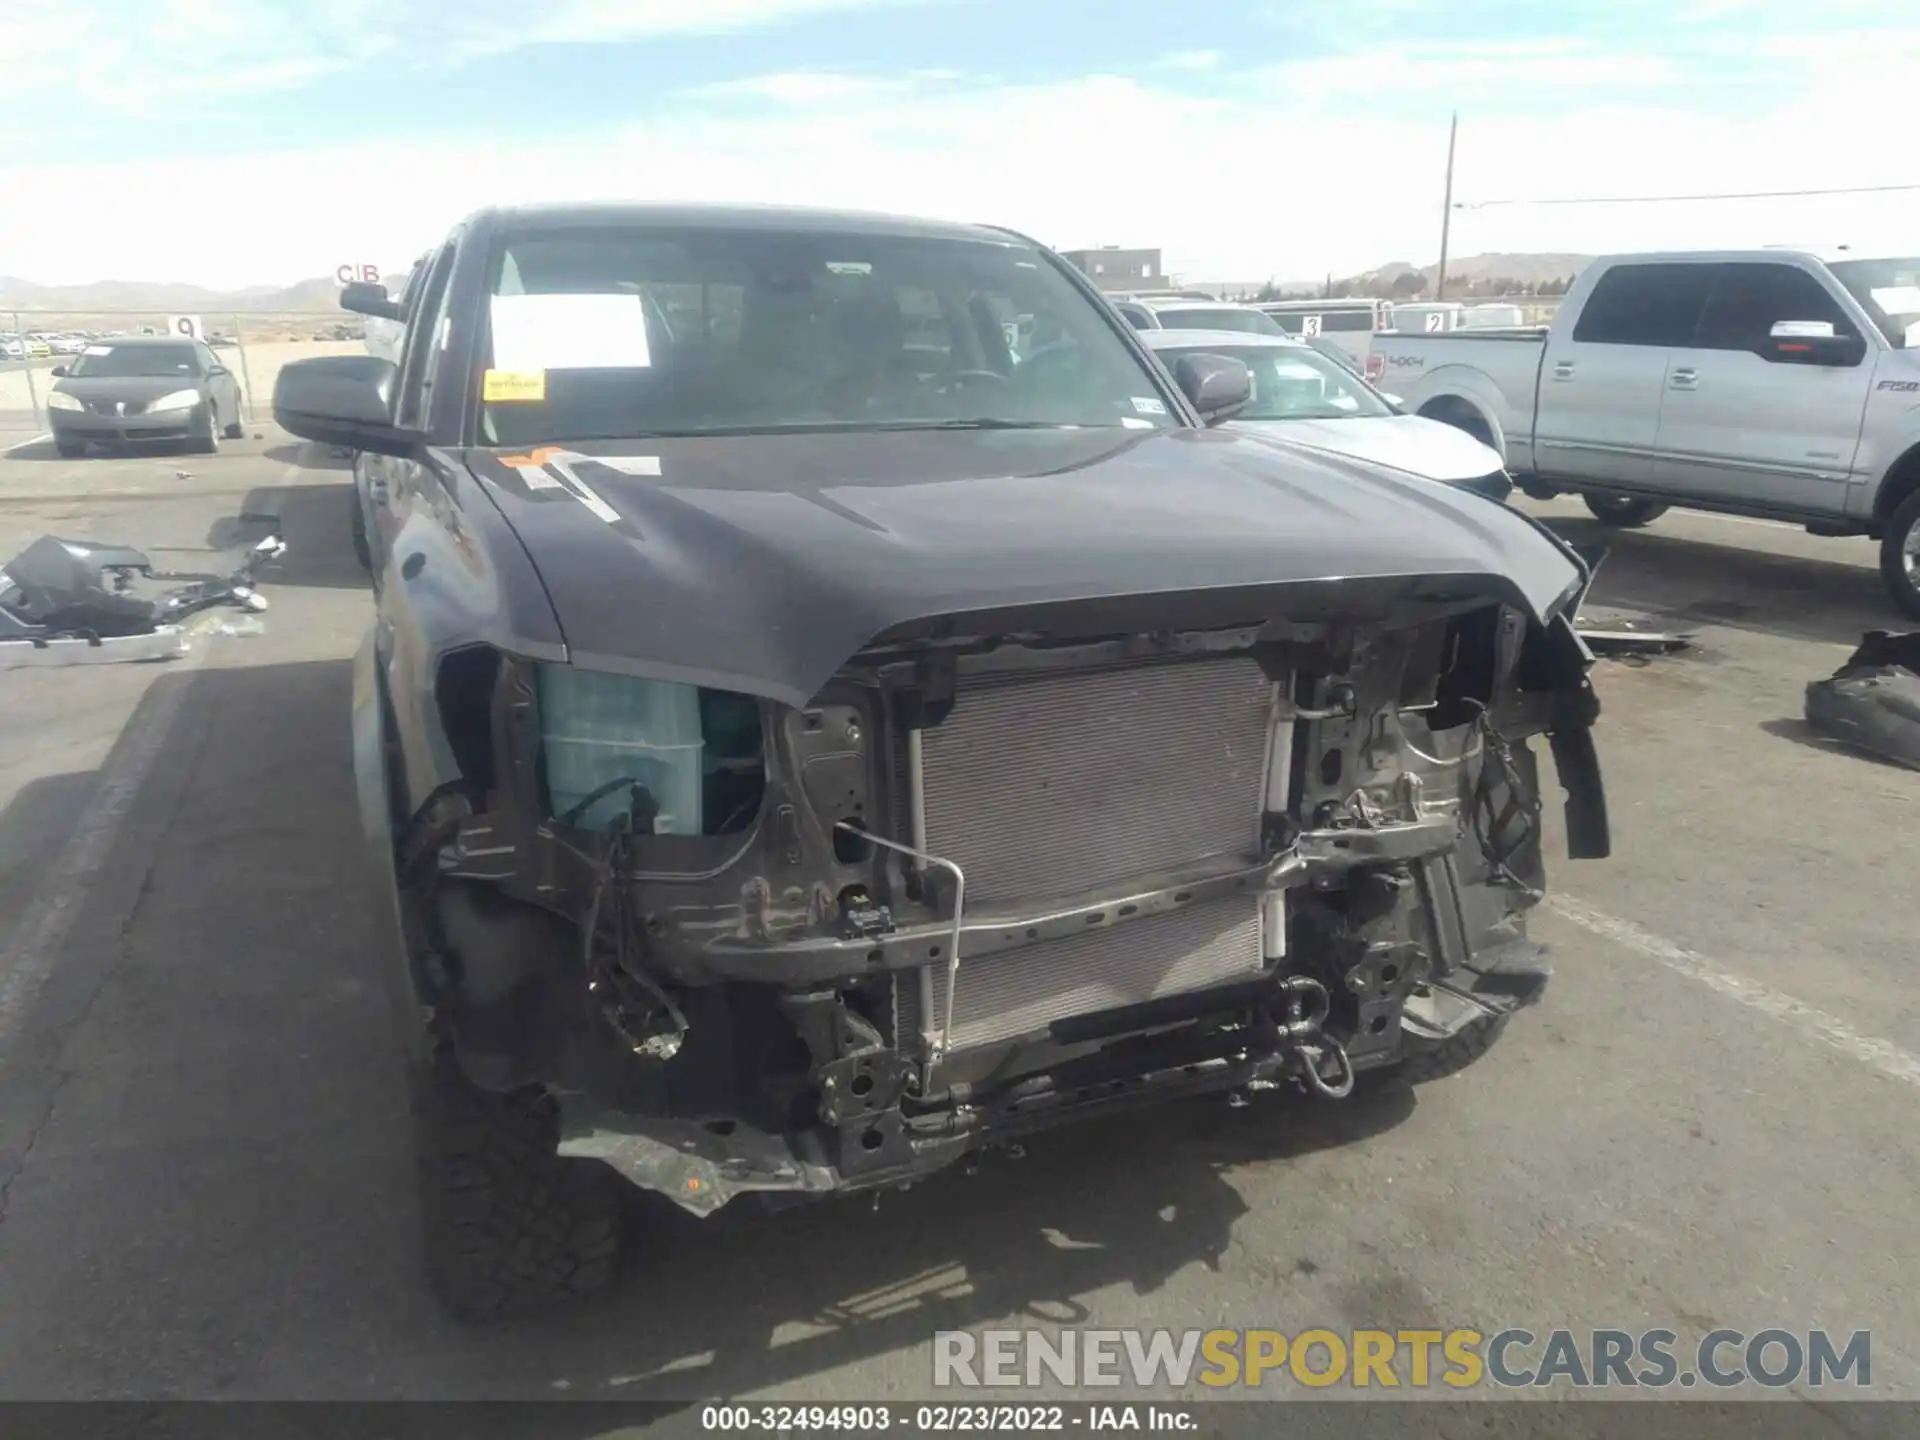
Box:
(0, 309, 365, 451)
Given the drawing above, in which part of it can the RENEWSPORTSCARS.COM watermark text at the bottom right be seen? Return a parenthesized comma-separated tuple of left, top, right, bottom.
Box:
(933, 1327, 1874, 1392)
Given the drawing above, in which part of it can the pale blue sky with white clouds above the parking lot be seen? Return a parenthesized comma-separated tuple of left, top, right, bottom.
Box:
(0, 0, 1920, 284)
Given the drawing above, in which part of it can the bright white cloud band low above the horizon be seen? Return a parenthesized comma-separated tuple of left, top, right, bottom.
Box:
(0, 46, 1920, 286)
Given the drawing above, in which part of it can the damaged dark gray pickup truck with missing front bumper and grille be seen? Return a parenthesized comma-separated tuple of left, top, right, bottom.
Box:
(275, 205, 1609, 1315)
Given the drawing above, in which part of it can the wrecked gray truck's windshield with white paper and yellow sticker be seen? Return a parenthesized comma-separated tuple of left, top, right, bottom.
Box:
(480, 228, 1179, 445)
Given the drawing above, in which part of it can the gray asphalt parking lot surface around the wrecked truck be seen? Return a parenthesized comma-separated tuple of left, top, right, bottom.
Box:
(0, 428, 1920, 1432)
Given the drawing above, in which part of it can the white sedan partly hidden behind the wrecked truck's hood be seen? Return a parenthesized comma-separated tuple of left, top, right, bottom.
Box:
(1139, 330, 1513, 501)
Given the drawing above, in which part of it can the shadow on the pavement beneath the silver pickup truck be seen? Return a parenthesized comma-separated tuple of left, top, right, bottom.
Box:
(1549, 518, 1903, 645)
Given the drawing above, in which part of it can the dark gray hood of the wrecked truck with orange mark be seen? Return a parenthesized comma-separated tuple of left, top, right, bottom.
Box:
(465, 430, 1586, 705)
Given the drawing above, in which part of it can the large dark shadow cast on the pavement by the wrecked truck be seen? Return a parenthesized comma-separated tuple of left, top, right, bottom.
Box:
(0, 660, 1413, 1413)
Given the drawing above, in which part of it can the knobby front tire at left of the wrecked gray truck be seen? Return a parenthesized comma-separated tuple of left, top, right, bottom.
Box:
(413, 1056, 620, 1321)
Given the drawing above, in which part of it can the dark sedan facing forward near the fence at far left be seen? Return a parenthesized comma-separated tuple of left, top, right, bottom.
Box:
(46, 336, 246, 457)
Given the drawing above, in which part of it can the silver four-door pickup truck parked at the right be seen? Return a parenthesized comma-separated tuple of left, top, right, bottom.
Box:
(1369, 250, 1920, 614)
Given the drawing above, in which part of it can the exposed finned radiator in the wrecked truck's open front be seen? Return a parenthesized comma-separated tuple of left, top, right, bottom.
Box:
(899, 657, 1273, 1050)
